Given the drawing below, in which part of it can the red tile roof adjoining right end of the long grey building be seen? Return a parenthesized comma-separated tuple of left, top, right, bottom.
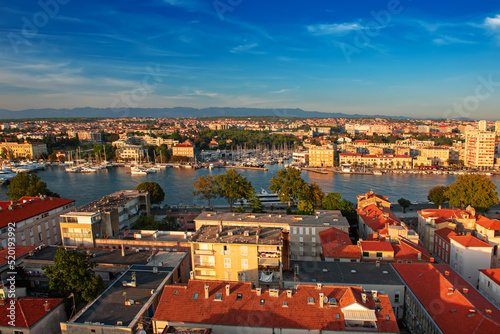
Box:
(319, 227, 361, 259)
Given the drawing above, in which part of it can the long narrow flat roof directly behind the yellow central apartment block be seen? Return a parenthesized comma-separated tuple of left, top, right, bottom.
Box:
(195, 210, 349, 226)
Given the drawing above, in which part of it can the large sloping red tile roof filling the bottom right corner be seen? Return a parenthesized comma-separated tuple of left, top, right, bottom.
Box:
(392, 263, 500, 334)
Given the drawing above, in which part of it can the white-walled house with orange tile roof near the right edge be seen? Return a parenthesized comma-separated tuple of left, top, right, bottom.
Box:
(450, 235, 493, 287)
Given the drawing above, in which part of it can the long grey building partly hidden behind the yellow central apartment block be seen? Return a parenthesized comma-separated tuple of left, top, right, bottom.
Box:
(194, 210, 349, 260)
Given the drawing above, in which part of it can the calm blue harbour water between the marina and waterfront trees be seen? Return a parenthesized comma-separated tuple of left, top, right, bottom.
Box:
(0, 165, 500, 205)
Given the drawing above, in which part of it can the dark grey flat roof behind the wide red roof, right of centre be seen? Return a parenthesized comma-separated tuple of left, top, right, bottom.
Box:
(283, 260, 404, 285)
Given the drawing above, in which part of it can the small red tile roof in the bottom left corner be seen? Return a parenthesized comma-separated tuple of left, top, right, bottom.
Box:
(0, 297, 63, 328)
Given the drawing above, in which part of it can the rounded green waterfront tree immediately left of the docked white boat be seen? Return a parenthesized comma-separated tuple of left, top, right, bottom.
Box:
(215, 169, 255, 211)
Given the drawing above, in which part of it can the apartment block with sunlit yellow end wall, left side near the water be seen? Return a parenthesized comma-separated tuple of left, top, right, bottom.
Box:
(60, 190, 151, 247)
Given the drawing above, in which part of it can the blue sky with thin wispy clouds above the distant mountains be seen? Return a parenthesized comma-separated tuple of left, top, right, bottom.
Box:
(0, 0, 500, 119)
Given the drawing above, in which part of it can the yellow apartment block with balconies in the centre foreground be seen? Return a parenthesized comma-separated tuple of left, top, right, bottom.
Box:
(190, 225, 289, 286)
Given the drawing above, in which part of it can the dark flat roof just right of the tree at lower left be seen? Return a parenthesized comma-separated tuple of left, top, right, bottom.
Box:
(71, 266, 171, 326)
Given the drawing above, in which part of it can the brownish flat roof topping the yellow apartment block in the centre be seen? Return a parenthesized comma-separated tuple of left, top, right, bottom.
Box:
(191, 225, 282, 245)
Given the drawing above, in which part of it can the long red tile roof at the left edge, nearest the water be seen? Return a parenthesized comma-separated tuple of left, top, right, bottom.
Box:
(0, 197, 75, 228)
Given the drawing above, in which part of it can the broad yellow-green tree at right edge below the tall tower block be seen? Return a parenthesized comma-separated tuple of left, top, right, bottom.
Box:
(447, 174, 498, 212)
